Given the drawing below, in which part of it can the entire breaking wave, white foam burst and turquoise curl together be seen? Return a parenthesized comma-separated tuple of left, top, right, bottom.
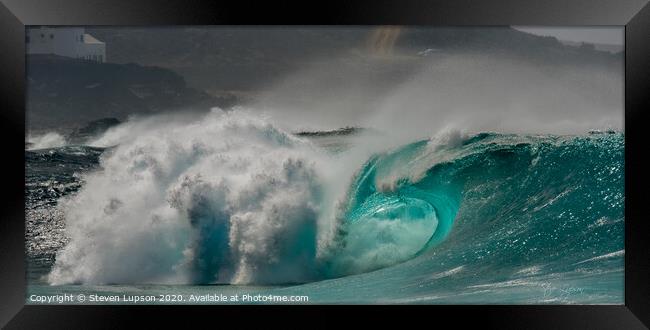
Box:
(48, 111, 624, 292)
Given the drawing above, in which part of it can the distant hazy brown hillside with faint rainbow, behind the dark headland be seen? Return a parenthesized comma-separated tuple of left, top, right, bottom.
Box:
(88, 27, 622, 95)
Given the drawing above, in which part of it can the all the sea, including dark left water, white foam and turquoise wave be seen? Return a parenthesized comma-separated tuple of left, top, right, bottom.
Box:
(25, 114, 625, 304)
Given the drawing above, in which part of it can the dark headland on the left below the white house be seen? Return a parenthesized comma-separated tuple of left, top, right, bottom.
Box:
(26, 55, 235, 129)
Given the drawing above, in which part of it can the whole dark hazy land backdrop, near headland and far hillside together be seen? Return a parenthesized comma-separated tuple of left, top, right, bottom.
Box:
(27, 27, 623, 129)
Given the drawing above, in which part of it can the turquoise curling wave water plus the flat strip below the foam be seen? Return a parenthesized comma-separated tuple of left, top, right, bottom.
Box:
(27, 133, 625, 304)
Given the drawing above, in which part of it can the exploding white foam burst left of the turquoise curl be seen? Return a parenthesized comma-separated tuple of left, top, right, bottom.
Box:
(49, 111, 330, 284)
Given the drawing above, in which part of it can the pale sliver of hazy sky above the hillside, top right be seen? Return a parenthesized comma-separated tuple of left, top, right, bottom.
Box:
(513, 26, 625, 45)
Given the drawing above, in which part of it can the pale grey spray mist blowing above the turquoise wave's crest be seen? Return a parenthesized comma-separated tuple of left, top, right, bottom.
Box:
(254, 54, 623, 139)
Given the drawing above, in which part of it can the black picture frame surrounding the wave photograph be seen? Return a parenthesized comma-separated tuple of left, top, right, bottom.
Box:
(0, 0, 650, 329)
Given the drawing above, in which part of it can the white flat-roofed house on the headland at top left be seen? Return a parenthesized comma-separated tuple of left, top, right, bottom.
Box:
(25, 26, 106, 62)
